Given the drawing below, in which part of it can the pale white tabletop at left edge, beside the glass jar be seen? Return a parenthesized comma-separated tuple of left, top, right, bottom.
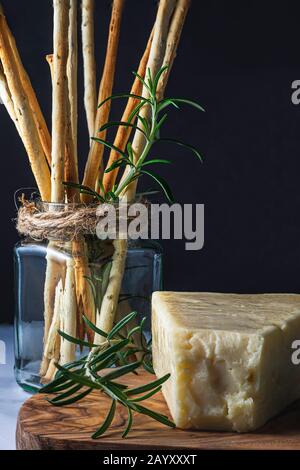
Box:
(0, 325, 30, 450)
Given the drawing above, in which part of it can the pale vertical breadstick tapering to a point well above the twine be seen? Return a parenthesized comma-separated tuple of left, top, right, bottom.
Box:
(81, 0, 97, 137)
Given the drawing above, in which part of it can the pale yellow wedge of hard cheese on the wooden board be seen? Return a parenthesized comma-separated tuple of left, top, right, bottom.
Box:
(152, 292, 300, 432)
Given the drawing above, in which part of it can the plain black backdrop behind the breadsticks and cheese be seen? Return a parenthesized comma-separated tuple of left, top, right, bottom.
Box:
(0, 0, 300, 321)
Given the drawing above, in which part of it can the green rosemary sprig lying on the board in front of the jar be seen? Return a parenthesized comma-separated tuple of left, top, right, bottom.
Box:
(40, 312, 175, 439)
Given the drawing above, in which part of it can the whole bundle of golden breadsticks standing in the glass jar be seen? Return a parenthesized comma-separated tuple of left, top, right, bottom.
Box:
(0, 0, 189, 381)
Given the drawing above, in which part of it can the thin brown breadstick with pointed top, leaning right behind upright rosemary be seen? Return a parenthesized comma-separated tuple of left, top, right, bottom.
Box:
(102, 31, 153, 192)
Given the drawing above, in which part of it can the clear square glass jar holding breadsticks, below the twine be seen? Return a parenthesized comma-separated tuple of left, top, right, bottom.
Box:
(14, 237, 162, 392)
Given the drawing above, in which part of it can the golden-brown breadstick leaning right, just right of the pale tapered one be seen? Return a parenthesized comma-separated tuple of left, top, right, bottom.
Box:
(82, 0, 124, 202)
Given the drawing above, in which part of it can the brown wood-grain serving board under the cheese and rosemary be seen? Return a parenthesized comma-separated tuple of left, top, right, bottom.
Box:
(16, 372, 300, 450)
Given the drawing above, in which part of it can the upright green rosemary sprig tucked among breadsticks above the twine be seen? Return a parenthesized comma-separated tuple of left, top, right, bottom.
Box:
(65, 66, 204, 202)
